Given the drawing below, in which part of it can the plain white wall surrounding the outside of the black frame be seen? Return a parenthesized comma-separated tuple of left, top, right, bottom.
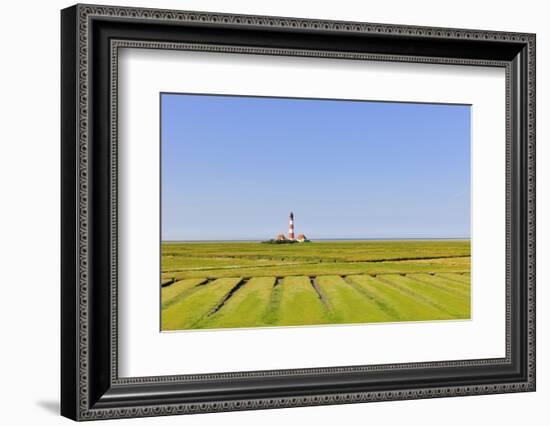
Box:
(0, 0, 550, 426)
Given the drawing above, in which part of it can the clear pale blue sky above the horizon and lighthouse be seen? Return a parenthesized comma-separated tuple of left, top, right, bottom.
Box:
(161, 94, 471, 241)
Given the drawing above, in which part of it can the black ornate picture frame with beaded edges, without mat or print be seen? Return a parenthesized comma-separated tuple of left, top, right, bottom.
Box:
(61, 5, 535, 420)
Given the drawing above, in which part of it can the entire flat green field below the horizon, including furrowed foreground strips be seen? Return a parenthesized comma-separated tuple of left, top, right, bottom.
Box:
(161, 240, 470, 331)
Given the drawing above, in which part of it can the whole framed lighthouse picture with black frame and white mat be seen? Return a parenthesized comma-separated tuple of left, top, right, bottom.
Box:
(61, 5, 535, 420)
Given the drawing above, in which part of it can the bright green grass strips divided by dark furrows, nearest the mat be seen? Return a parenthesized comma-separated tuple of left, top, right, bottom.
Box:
(161, 272, 470, 331)
